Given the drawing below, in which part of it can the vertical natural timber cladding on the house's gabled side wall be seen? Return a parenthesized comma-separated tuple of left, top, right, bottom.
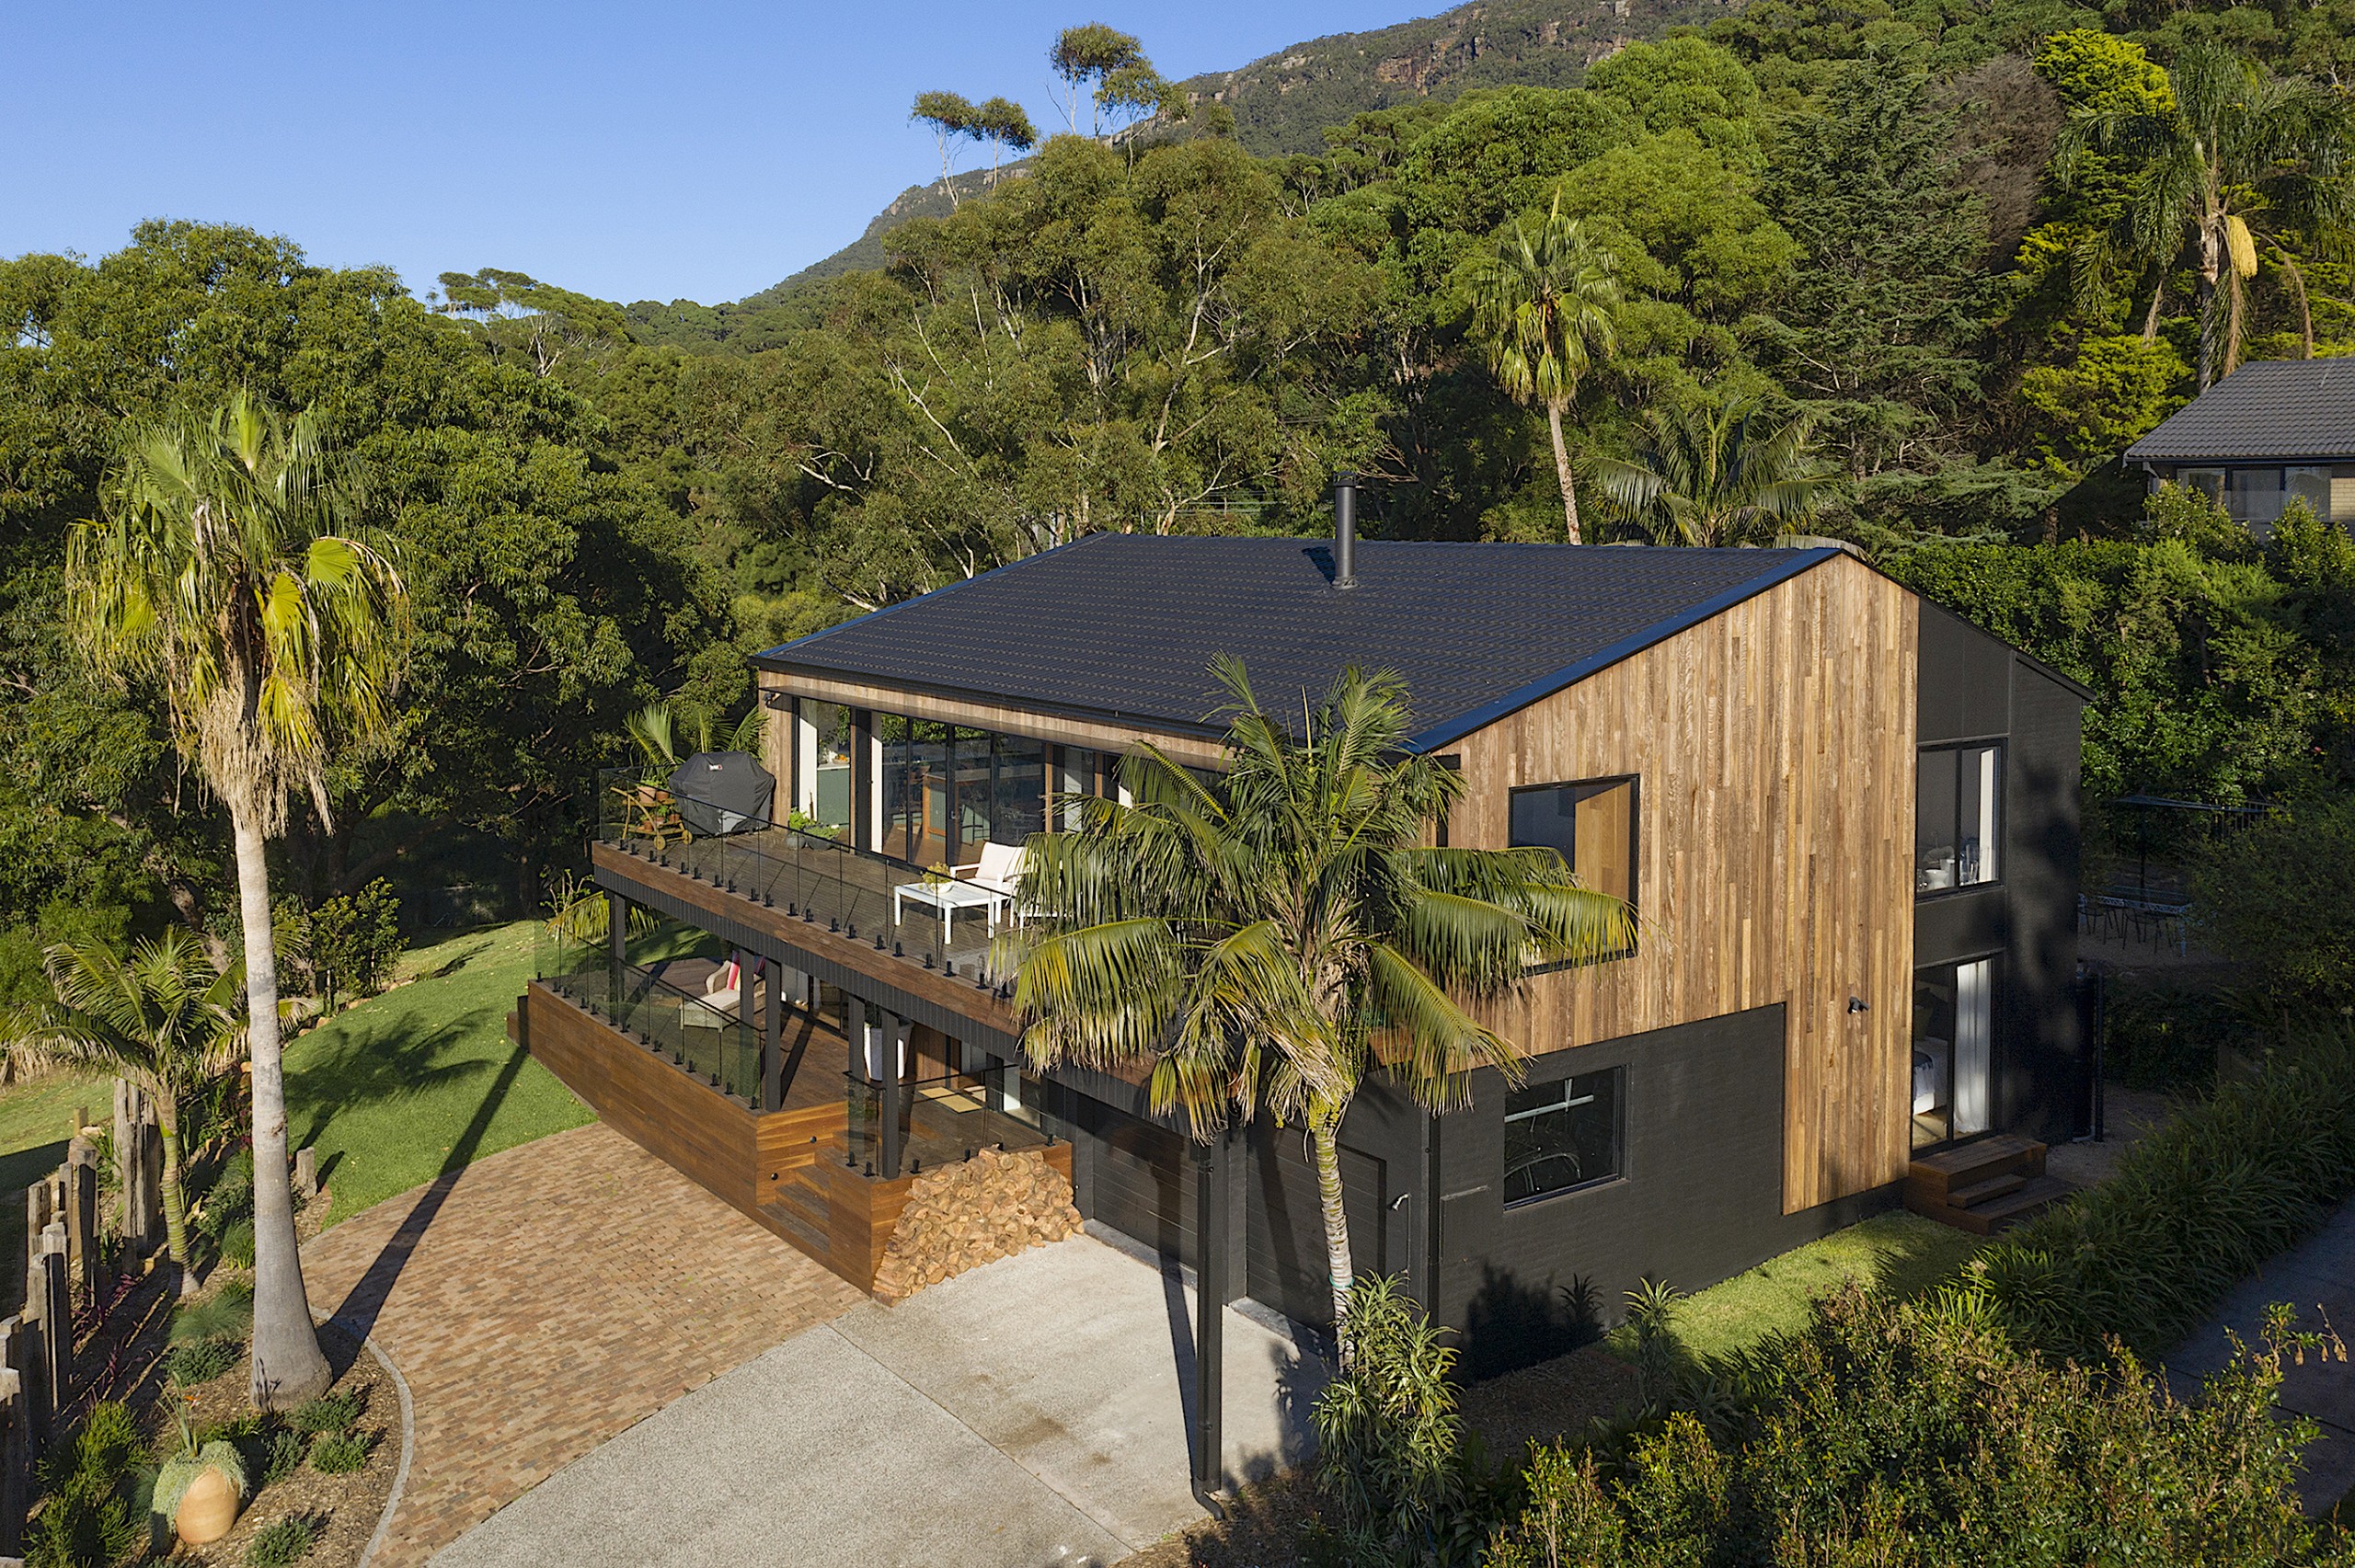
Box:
(1448, 555, 1919, 1212)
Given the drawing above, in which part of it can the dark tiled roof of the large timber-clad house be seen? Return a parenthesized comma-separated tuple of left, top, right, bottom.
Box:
(753, 534, 1839, 751)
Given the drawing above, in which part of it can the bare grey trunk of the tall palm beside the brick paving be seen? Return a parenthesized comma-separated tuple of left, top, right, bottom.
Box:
(228, 789, 335, 1410)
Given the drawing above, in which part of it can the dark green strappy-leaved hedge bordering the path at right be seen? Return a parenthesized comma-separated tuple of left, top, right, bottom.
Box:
(1971, 1022, 2355, 1361)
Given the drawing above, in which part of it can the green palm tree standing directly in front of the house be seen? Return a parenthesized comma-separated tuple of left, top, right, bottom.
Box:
(1008, 659, 1630, 1354)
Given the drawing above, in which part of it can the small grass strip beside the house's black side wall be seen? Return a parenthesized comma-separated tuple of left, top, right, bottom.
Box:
(1608, 1210, 1981, 1356)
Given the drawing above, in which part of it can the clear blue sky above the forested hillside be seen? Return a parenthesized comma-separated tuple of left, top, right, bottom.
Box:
(0, 0, 1384, 303)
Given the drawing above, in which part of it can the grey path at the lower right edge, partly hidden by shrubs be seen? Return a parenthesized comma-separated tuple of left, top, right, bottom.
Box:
(2166, 1203, 2355, 1514)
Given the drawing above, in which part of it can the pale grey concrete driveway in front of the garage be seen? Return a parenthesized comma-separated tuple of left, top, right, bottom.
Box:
(433, 1236, 1324, 1568)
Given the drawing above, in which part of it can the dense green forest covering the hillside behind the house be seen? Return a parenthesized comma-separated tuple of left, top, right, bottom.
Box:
(0, 0, 2355, 991)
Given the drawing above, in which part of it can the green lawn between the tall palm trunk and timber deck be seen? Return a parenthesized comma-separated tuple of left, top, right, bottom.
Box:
(287, 921, 593, 1222)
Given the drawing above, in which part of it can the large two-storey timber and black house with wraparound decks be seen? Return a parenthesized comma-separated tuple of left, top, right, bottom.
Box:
(516, 482, 2089, 1370)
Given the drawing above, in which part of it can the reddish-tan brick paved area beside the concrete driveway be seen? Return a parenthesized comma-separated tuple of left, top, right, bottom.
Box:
(304, 1126, 865, 1568)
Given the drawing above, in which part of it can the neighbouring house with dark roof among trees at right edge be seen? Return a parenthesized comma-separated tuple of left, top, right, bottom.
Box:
(2127, 358, 2355, 537)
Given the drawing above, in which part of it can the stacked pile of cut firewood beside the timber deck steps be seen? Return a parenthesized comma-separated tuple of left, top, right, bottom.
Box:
(876, 1149, 1081, 1302)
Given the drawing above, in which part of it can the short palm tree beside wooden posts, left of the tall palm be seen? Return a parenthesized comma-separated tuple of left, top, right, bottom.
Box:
(9, 930, 245, 1292)
